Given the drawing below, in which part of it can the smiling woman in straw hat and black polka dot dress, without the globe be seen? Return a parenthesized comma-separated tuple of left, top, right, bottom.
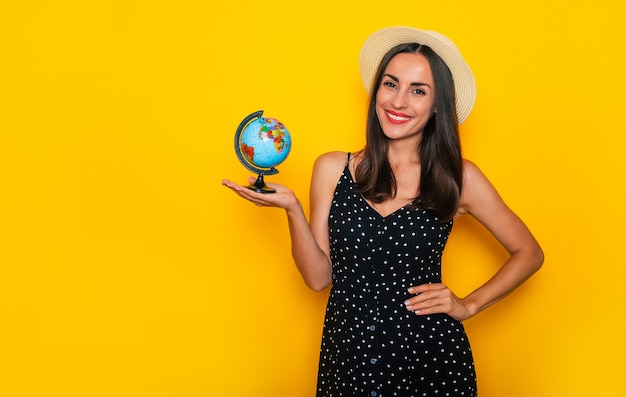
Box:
(223, 27, 543, 397)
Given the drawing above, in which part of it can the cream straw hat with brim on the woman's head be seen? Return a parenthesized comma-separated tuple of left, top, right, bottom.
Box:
(360, 26, 476, 124)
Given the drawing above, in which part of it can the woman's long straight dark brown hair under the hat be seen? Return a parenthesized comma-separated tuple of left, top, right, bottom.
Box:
(355, 43, 463, 222)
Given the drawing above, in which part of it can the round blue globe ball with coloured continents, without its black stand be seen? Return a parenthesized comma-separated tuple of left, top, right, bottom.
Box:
(240, 117, 291, 168)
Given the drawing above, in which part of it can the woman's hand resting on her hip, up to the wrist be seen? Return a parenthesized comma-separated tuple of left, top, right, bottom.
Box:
(404, 283, 474, 321)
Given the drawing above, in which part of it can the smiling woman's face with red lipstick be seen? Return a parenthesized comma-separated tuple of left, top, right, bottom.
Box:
(376, 53, 435, 139)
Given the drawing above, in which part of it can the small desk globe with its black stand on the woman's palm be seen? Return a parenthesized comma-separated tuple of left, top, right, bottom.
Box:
(235, 111, 291, 193)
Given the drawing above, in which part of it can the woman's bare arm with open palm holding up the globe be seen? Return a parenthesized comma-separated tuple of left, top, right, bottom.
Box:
(222, 152, 346, 291)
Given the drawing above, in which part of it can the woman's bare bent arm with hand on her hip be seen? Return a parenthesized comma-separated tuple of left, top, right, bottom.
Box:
(405, 160, 543, 320)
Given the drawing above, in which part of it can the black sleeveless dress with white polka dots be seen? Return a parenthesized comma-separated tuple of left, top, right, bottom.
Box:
(317, 159, 476, 397)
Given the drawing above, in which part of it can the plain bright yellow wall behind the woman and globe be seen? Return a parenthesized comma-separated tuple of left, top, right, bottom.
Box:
(0, 0, 626, 397)
